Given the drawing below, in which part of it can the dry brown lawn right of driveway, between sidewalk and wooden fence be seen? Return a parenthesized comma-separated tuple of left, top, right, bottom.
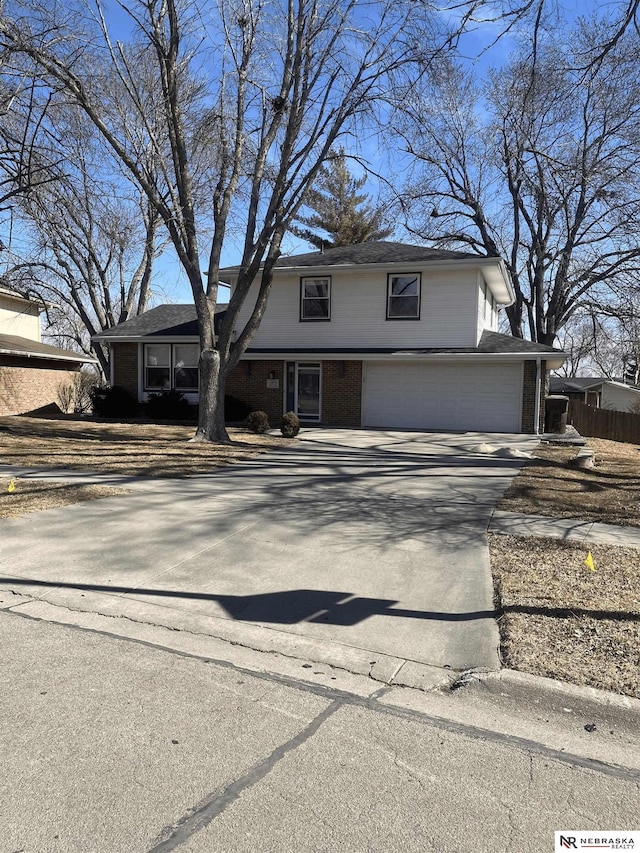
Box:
(498, 438, 640, 527)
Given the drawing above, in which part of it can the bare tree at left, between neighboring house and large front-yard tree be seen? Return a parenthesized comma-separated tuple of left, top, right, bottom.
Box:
(9, 125, 162, 377)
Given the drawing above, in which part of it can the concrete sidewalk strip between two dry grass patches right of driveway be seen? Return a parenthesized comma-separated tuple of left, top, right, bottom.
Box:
(488, 510, 640, 548)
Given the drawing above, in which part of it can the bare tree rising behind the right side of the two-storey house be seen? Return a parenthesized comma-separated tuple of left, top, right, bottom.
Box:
(405, 21, 640, 345)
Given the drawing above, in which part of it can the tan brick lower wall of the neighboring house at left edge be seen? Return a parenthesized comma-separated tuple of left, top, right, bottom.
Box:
(0, 357, 80, 415)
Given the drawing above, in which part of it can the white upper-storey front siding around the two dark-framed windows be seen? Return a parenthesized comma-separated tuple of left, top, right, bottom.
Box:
(238, 265, 478, 348)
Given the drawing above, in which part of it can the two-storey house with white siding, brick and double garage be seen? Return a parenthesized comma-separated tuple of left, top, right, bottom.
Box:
(97, 242, 564, 433)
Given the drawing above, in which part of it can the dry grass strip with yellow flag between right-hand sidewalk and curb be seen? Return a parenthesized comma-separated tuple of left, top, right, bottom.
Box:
(489, 534, 640, 698)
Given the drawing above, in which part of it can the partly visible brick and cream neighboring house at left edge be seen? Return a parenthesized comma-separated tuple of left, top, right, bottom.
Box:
(0, 286, 93, 415)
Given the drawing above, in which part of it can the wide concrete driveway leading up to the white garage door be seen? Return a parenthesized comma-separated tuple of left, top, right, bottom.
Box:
(0, 429, 537, 680)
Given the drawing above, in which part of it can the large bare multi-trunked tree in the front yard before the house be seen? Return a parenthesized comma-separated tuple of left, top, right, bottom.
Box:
(0, 0, 537, 441)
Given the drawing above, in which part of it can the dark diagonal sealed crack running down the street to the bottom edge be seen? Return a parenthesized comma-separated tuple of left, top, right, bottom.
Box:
(149, 699, 345, 853)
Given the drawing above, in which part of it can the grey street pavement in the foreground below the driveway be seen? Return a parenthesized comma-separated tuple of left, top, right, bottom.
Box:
(0, 611, 640, 853)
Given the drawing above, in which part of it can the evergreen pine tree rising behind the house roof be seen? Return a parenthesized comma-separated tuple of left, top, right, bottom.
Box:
(290, 149, 392, 249)
